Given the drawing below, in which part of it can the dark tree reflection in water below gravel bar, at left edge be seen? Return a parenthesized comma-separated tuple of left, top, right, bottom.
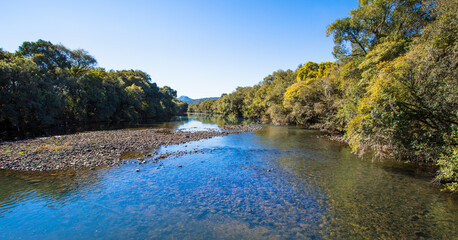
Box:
(0, 167, 102, 213)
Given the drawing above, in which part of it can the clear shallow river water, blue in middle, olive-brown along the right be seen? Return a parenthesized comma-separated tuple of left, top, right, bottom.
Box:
(0, 116, 458, 239)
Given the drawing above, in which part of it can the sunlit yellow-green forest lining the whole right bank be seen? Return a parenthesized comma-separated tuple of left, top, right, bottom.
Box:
(188, 0, 458, 192)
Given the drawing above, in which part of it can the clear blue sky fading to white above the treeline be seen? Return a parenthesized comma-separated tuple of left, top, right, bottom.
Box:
(0, 0, 358, 99)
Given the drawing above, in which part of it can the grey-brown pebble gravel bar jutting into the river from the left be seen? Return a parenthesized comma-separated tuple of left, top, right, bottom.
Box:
(0, 125, 261, 171)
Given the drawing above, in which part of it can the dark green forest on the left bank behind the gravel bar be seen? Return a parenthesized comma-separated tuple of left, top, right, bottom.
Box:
(0, 40, 187, 136)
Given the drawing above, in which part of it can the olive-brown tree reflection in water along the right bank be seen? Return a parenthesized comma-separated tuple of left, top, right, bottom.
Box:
(258, 127, 458, 239)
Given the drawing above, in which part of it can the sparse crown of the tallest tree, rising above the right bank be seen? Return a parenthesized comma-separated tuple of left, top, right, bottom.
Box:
(327, 0, 434, 59)
